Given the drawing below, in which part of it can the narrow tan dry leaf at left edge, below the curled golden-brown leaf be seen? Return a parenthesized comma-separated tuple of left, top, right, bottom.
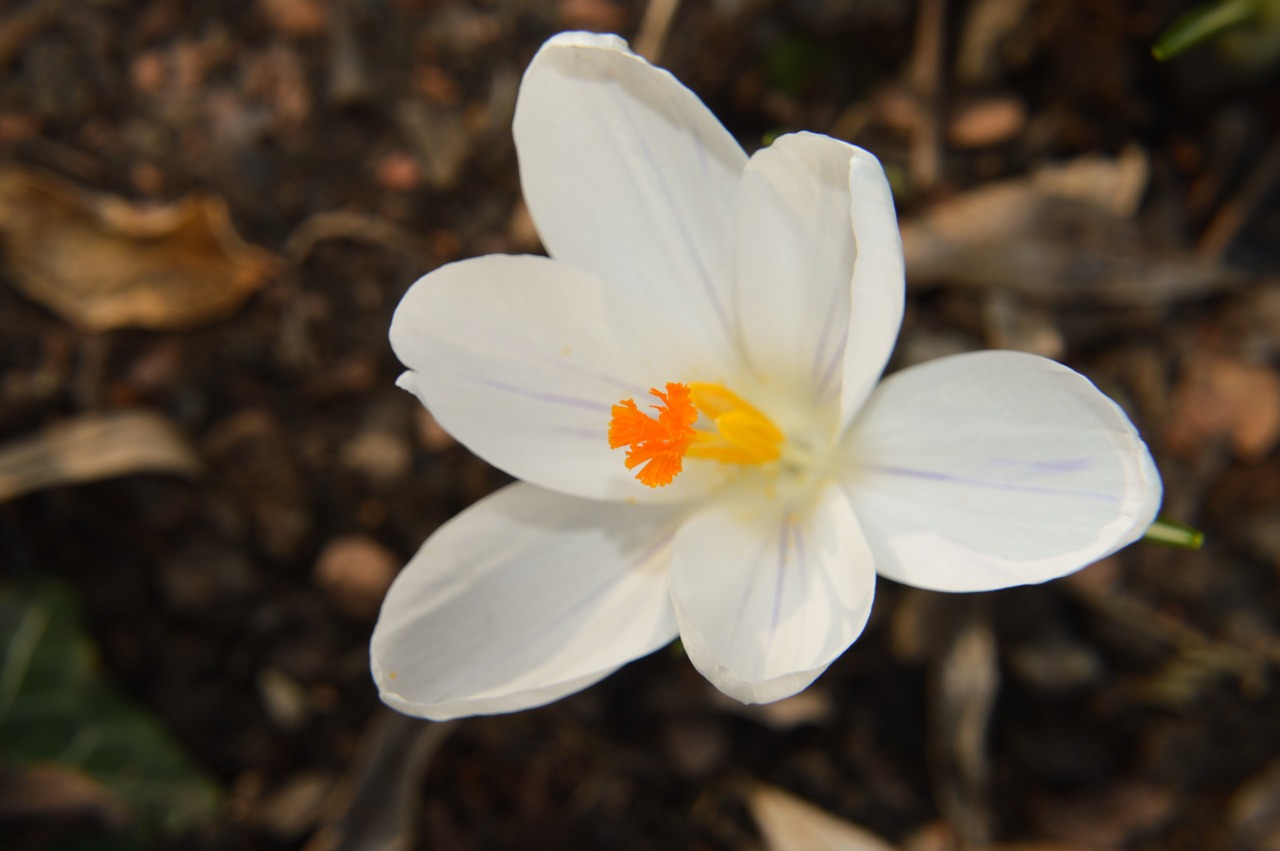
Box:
(0, 411, 200, 500)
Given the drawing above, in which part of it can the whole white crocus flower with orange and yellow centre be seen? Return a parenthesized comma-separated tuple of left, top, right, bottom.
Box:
(371, 33, 1160, 719)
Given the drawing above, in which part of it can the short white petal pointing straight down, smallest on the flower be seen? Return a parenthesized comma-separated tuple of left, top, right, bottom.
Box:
(671, 485, 876, 703)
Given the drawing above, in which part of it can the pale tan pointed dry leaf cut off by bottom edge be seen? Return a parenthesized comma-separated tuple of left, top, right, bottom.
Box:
(748, 784, 897, 851)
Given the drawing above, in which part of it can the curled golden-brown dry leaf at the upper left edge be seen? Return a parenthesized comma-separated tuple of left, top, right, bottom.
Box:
(0, 166, 279, 330)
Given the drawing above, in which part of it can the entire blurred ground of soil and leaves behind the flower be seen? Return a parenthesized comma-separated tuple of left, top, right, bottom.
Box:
(0, 0, 1280, 851)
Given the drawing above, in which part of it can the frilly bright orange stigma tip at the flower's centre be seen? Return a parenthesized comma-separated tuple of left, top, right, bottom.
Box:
(609, 381, 698, 488)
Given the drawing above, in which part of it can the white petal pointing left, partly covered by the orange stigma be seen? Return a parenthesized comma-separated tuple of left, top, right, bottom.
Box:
(390, 255, 724, 500)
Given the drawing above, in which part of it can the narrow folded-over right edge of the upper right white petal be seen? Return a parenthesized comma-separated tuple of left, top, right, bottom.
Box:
(841, 148, 906, 424)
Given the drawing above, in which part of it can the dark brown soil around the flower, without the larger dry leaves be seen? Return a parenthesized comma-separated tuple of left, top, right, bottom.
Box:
(0, 0, 1280, 851)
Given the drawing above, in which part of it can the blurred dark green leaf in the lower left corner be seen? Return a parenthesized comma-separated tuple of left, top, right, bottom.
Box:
(0, 584, 221, 847)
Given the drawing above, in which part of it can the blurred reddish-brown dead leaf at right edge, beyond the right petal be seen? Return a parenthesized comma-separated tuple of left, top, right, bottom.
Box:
(1165, 356, 1280, 461)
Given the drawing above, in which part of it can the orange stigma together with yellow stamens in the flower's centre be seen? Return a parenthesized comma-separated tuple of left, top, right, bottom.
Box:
(609, 381, 783, 488)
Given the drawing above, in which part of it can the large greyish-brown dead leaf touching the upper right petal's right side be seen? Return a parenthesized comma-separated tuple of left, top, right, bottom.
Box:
(902, 154, 1239, 307)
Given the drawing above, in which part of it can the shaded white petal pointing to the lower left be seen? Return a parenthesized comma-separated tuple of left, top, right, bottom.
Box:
(370, 484, 676, 720)
